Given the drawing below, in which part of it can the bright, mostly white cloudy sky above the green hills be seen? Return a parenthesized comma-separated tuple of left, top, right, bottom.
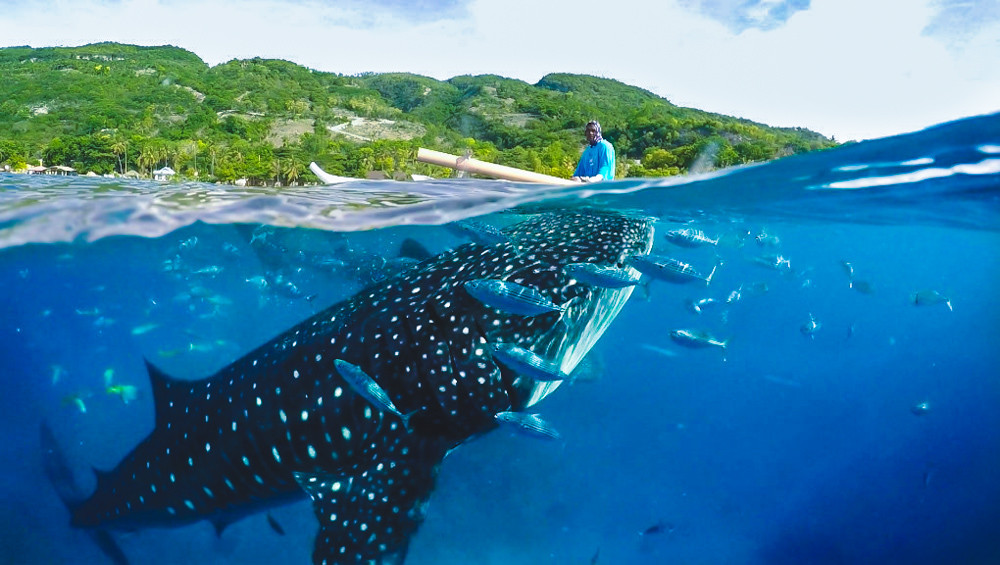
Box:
(0, 0, 1000, 141)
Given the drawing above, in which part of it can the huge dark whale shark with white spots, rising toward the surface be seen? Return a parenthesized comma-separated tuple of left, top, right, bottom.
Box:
(49, 210, 653, 565)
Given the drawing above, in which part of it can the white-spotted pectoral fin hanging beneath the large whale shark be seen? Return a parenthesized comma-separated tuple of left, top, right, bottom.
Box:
(295, 441, 443, 565)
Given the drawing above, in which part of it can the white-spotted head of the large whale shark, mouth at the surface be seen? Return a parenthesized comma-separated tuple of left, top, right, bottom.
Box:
(351, 210, 653, 443)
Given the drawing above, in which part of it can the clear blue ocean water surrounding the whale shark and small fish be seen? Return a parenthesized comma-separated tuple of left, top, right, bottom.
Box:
(0, 115, 1000, 565)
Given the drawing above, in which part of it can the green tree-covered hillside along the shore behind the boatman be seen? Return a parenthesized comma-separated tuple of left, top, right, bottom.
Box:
(0, 43, 835, 184)
